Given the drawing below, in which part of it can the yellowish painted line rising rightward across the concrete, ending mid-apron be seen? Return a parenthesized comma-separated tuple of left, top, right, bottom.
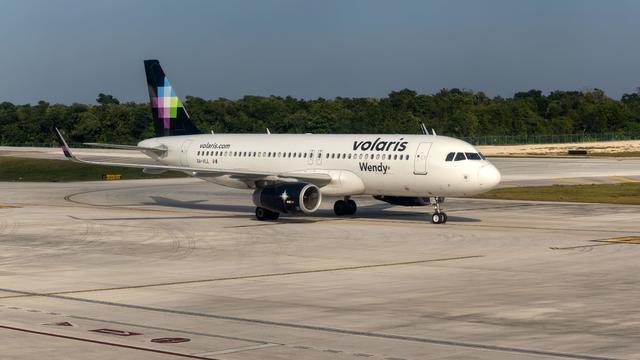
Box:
(0, 255, 484, 299)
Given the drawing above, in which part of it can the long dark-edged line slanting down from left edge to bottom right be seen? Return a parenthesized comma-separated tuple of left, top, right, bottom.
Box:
(0, 289, 619, 360)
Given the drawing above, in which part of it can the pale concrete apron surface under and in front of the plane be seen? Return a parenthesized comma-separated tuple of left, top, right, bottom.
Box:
(0, 170, 640, 360)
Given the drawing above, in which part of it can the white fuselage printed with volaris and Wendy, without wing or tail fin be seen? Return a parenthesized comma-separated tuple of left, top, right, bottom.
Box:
(139, 134, 500, 197)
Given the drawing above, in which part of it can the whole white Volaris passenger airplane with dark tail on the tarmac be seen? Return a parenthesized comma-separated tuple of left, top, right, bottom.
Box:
(56, 60, 500, 224)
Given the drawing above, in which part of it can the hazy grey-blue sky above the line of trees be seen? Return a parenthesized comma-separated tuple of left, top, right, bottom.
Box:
(0, 0, 640, 104)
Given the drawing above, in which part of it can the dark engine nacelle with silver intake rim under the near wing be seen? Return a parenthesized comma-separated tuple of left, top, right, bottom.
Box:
(253, 183, 322, 214)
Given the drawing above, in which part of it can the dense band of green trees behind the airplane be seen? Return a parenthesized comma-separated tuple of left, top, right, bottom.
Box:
(0, 89, 640, 144)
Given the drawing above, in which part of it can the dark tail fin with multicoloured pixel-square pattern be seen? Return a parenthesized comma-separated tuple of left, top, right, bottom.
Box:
(144, 60, 201, 136)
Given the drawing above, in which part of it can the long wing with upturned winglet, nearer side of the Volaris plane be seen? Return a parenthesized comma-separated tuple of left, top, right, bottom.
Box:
(56, 128, 331, 187)
